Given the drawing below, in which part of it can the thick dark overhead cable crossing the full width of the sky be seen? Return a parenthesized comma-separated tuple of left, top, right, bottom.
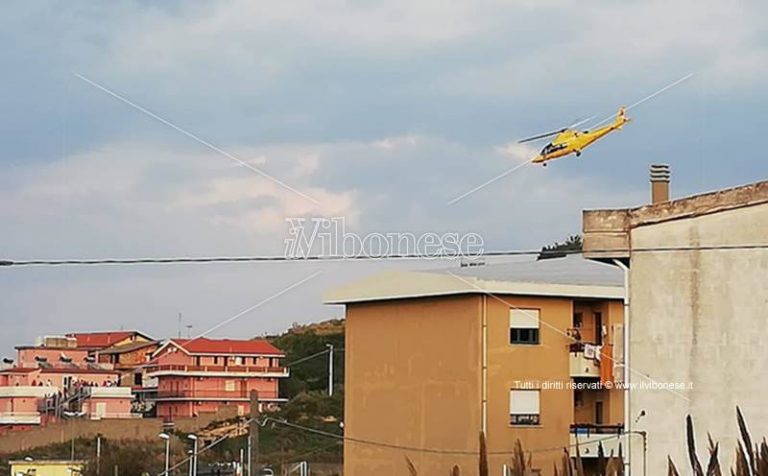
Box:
(0, 243, 768, 267)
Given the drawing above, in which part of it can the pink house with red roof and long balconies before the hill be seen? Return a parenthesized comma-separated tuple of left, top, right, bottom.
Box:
(147, 338, 288, 419)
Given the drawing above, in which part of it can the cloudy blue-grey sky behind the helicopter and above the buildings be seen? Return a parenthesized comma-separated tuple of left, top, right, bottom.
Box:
(0, 0, 768, 355)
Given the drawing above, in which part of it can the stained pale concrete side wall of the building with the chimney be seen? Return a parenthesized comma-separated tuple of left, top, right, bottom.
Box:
(630, 204, 768, 475)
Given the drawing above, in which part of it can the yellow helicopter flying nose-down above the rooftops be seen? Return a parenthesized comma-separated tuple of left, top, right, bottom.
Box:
(518, 107, 631, 167)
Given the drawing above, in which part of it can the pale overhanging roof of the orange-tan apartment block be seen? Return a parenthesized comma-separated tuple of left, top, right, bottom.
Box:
(324, 255, 624, 304)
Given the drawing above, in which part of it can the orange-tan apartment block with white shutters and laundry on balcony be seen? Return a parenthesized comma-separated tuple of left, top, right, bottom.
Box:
(326, 257, 624, 476)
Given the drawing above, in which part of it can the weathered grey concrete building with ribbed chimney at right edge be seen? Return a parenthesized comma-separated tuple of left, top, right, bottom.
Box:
(584, 166, 768, 475)
